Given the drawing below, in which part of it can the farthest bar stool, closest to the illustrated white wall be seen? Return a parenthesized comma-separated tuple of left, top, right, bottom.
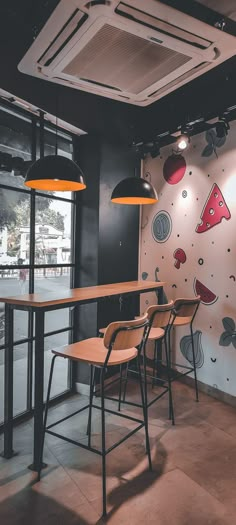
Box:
(168, 295, 201, 401)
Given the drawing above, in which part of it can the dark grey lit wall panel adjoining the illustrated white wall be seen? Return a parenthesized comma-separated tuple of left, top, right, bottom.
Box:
(98, 142, 139, 327)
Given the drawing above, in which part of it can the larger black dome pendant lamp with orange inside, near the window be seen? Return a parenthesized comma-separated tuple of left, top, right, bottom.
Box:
(25, 155, 86, 191)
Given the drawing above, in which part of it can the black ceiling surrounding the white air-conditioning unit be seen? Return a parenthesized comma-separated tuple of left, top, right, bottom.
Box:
(0, 0, 236, 143)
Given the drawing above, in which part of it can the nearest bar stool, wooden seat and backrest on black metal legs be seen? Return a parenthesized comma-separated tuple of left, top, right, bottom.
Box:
(38, 315, 152, 516)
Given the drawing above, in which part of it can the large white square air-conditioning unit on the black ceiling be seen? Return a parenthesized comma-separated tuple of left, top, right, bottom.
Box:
(18, 0, 236, 106)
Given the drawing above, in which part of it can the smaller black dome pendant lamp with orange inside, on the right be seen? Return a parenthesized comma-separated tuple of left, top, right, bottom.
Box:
(111, 177, 158, 204)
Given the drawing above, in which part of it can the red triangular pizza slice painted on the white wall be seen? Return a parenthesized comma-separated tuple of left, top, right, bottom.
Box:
(196, 183, 231, 233)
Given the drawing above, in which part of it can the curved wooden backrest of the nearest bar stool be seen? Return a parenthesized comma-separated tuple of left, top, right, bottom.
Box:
(103, 314, 148, 350)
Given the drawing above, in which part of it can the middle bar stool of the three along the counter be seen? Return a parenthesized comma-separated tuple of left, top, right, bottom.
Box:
(99, 301, 175, 425)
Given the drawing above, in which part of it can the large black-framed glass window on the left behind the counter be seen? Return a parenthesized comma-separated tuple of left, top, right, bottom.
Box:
(0, 103, 75, 424)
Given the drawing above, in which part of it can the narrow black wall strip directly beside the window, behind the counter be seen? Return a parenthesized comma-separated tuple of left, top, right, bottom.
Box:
(75, 135, 100, 383)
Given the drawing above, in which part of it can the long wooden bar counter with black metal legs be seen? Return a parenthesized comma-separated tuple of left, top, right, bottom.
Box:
(0, 281, 165, 470)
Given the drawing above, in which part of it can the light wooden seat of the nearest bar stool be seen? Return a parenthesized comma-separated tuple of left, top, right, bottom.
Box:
(52, 337, 138, 366)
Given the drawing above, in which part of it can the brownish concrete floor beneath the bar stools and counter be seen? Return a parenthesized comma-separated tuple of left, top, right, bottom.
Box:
(0, 383, 236, 525)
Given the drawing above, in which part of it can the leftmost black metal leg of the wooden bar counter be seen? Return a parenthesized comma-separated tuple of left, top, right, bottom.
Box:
(3, 304, 14, 459)
